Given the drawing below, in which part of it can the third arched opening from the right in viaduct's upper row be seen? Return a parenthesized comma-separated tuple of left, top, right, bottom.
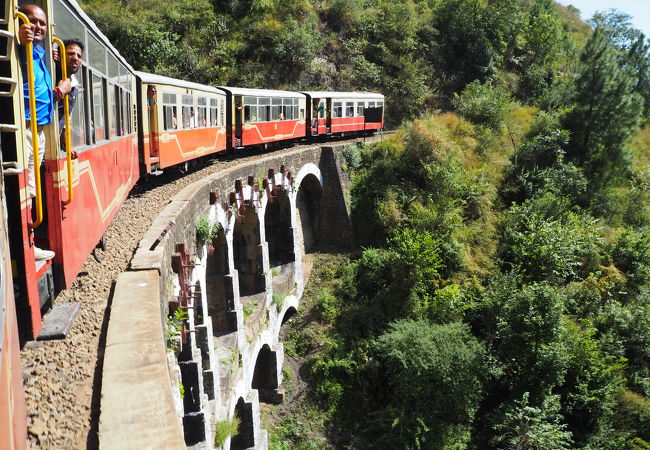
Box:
(233, 207, 266, 296)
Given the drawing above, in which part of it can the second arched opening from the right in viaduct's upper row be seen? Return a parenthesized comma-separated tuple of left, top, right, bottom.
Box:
(264, 190, 296, 267)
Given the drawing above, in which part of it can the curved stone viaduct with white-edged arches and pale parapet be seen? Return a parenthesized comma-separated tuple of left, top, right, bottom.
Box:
(99, 146, 351, 449)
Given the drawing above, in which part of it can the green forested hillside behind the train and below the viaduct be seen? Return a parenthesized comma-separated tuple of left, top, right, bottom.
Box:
(80, 0, 650, 450)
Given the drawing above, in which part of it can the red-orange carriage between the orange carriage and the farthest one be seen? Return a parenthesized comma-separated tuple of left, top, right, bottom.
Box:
(219, 86, 306, 148)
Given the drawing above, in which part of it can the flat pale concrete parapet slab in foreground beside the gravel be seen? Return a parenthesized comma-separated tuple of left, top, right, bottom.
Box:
(99, 271, 185, 450)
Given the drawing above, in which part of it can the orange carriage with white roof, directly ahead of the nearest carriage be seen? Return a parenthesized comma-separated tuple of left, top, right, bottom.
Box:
(137, 72, 226, 174)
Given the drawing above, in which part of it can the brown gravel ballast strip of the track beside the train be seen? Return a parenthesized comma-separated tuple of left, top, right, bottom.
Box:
(21, 136, 380, 449)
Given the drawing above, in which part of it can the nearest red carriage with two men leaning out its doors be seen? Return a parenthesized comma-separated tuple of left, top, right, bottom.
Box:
(0, 0, 139, 339)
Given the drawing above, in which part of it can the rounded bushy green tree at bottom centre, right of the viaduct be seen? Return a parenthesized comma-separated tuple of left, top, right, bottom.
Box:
(373, 320, 485, 448)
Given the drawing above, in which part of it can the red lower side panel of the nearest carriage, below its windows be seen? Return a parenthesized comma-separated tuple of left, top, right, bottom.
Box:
(46, 135, 139, 287)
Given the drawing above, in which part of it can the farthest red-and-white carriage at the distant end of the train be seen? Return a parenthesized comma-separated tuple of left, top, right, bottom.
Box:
(303, 91, 384, 136)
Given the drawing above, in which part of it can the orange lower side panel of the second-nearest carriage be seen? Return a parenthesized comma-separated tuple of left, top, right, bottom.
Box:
(156, 127, 226, 168)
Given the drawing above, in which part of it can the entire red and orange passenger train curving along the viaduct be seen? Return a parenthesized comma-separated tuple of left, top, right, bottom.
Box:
(0, 0, 384, 442)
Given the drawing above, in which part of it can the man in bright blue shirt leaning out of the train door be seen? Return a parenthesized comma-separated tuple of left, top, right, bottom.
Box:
(18, 4, 71, 261)
